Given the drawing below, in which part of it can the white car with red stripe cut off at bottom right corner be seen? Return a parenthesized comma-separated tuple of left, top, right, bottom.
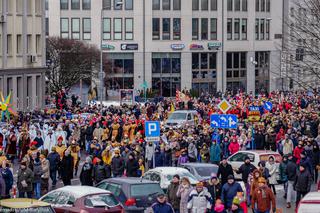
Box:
(297, 192, 320, 213)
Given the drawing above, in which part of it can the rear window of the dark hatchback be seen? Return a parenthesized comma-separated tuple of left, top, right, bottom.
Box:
(131, 183, 163, 197)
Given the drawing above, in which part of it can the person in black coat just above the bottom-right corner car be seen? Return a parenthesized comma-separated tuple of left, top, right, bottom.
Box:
(293, 164, 312, 207)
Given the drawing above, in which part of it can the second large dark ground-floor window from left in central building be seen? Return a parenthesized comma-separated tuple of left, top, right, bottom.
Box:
(152, 53, 181, 97)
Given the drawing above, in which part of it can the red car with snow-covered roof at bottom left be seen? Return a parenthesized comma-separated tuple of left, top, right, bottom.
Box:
(40, 186, 123, 213)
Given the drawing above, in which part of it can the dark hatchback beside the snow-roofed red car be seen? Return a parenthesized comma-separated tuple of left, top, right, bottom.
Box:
(96, 177, 163, 213)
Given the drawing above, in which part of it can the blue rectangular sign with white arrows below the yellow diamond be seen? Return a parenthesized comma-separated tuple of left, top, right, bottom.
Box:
(210, 114, 238, 129)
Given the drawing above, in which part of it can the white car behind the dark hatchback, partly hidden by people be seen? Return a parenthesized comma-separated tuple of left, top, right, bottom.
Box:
(143, 167, 199, 191)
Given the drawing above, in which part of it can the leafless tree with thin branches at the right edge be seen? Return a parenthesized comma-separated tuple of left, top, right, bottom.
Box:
(282, 0, 320, 89)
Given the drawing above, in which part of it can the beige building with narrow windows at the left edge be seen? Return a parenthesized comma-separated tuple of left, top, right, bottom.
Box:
(0, 0, 45, 111)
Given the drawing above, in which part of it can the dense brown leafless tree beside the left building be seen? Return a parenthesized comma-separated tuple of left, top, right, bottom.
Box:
(46, 37, 99, 92)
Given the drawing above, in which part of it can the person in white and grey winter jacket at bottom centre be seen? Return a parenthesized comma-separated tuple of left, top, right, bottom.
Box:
(187, 182, 211, 213)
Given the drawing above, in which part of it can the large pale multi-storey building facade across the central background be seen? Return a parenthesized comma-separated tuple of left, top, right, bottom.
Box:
(47, 0, 282, 96)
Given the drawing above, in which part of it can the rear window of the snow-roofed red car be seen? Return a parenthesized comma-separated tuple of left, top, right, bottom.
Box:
(84, 194, 119, 208)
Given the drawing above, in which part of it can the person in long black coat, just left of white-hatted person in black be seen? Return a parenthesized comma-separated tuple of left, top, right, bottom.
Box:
(60, 150, 74, 186)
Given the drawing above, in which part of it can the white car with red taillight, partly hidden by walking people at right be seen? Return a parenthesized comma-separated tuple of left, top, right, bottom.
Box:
(228, 150, 282, 180)
